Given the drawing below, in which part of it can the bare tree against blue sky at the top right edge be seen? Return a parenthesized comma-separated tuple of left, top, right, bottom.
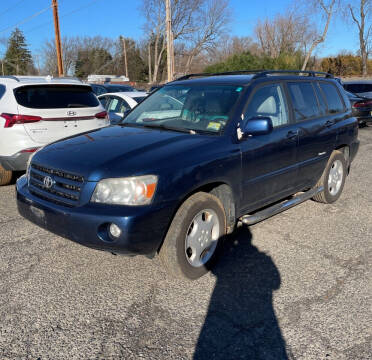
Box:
(348, 0, 372, 76)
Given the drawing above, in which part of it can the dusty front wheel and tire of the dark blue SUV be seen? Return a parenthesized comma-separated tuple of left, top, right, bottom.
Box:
(159, 192, 226, 280)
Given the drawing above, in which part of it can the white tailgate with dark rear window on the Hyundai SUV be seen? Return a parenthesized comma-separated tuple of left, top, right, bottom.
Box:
(14, 84, 109, 143)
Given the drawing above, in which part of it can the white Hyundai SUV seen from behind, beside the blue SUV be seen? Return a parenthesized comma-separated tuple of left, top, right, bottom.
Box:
(0, 76, 109, 185)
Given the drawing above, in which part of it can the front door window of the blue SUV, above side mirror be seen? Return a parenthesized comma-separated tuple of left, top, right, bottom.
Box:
(244, 84, 289, 127)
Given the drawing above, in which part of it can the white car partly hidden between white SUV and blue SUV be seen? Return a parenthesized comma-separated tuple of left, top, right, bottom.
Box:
(98, 91, 148, 124)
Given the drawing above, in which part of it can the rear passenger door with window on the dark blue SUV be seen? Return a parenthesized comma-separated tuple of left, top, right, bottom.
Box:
(287, 81, 337, 190)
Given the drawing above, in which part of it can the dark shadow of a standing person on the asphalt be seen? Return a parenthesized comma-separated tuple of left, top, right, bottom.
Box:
(193, 227, 291, 360)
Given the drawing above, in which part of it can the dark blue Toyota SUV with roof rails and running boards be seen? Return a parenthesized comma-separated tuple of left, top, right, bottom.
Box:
(17, 71, 359, 279)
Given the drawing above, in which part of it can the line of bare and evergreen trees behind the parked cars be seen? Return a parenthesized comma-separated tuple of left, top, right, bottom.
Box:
(1, 0, 372, 83)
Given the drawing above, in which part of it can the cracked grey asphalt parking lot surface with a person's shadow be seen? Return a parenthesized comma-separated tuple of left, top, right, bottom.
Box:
(0, 127, 372, 360)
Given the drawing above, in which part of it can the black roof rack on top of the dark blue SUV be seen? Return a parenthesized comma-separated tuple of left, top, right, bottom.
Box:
(174, 70, 333, 81)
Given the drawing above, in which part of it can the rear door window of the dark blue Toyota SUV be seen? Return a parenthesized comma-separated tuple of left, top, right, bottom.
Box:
(288, 82, 320, 121)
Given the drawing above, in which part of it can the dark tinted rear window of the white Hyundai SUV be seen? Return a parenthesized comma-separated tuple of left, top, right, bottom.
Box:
(14, 85, 99, 109)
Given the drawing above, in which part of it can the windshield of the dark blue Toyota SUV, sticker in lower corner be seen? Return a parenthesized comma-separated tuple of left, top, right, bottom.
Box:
(122, 85, 243, 133)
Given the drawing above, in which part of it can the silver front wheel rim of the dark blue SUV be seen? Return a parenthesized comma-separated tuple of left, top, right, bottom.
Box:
(185, 209, 220, 267)
